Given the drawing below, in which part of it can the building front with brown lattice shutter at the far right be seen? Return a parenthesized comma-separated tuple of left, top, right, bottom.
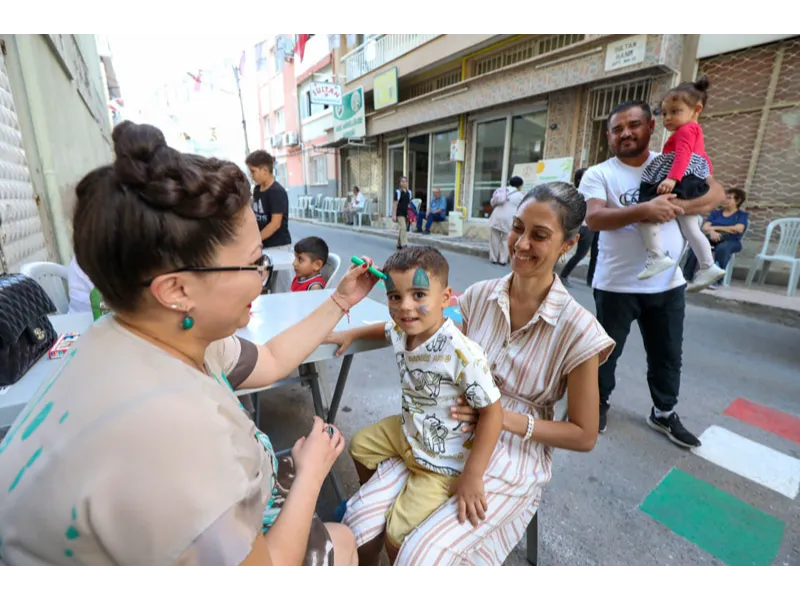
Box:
(696, 32, 800, 241)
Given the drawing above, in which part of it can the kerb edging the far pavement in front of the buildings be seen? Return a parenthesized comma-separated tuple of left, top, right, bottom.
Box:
(292, 217, 800, 329)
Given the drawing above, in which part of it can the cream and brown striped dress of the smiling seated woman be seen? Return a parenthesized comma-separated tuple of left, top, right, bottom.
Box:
(344, 275, 614, 567)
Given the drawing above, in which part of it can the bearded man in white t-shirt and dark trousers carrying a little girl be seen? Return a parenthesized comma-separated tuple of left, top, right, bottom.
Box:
(580, 102, 725, 448)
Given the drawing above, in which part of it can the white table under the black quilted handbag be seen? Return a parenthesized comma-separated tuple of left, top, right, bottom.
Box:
(0, 313, 94, 429)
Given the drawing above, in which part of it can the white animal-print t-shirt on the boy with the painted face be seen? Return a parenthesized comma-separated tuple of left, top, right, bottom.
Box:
(386, 319, 500, 477)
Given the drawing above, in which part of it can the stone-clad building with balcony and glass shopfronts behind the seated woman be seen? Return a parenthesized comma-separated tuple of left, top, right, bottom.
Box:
(318, 33, 686, 237)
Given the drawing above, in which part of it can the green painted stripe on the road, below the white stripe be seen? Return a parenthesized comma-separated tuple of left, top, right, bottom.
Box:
(639, 469, 785, 567)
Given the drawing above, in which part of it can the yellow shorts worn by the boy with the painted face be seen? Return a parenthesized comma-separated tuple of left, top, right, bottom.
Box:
(350, 415, 456, 548)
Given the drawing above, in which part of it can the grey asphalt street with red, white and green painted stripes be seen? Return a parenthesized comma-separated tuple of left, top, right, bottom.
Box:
(261, 224, 800, 566)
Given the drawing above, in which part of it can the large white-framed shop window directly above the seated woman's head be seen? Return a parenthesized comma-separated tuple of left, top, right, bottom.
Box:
(472, 111, 547, 218)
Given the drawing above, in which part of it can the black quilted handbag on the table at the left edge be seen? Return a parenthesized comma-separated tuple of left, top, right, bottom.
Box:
(0, 273, 58, 386)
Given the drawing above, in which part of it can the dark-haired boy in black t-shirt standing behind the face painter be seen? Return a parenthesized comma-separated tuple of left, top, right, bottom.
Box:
(245, 150, 292, 293)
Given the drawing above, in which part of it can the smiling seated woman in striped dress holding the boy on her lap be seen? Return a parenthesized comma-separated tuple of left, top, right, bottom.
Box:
(344, 182, 614, 566)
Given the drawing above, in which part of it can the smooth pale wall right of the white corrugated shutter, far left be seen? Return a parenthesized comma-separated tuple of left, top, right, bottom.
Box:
(4, 33, 112, 263)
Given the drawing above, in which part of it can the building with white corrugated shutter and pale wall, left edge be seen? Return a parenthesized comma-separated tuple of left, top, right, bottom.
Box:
(0, 33, 112, 272)
